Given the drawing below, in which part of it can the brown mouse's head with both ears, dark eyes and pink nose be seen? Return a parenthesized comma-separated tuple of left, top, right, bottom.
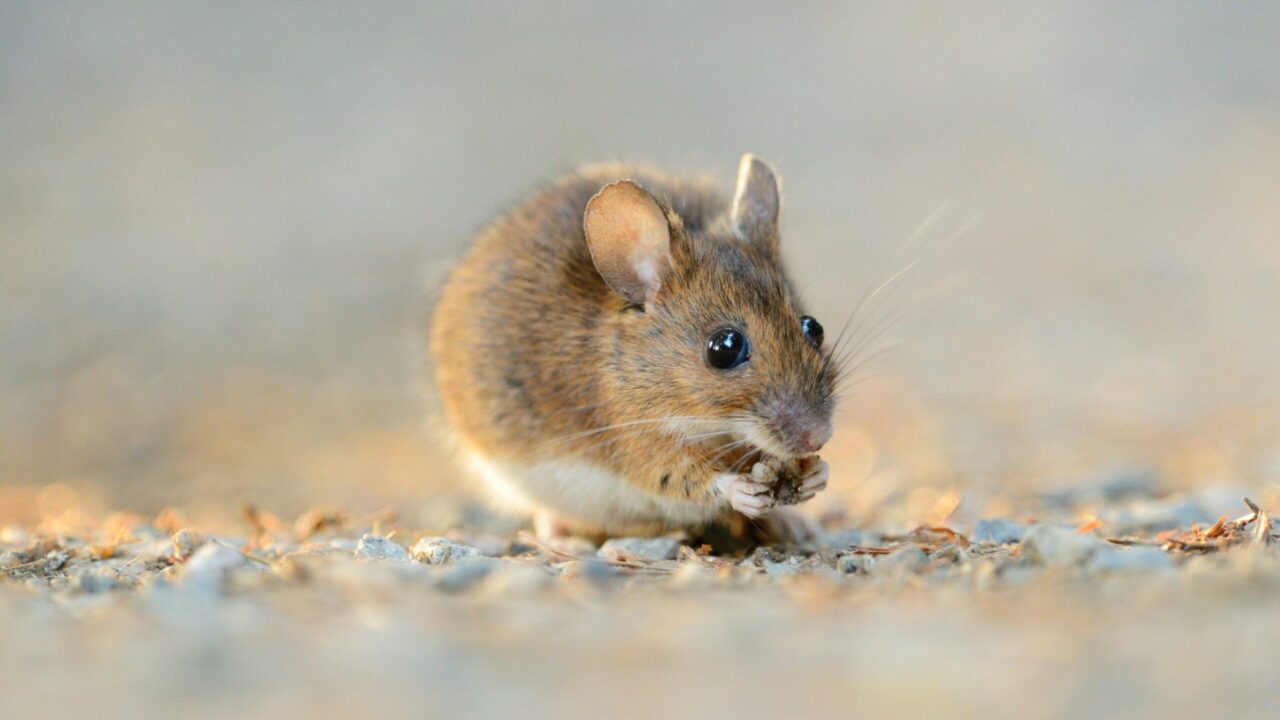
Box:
(584, 155, 836, 459)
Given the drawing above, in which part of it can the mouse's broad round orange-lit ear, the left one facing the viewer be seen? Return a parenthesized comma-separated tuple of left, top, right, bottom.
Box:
(582, 181, 671, 305)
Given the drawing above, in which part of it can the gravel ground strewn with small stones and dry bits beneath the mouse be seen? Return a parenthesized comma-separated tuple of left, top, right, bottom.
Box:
(0, 486, 1280, 719)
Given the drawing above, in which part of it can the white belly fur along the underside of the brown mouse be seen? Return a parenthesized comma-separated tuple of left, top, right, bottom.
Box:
(467, 452, 723, 529)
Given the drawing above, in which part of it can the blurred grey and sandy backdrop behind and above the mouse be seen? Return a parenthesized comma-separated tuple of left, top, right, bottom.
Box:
(0, 1, 1280, 525)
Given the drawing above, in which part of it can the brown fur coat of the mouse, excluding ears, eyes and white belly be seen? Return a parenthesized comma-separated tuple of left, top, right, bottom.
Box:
(431, 156, 836, 532)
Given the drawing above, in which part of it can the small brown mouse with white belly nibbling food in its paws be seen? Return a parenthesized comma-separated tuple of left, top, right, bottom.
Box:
(429, 154, 838, 539)
